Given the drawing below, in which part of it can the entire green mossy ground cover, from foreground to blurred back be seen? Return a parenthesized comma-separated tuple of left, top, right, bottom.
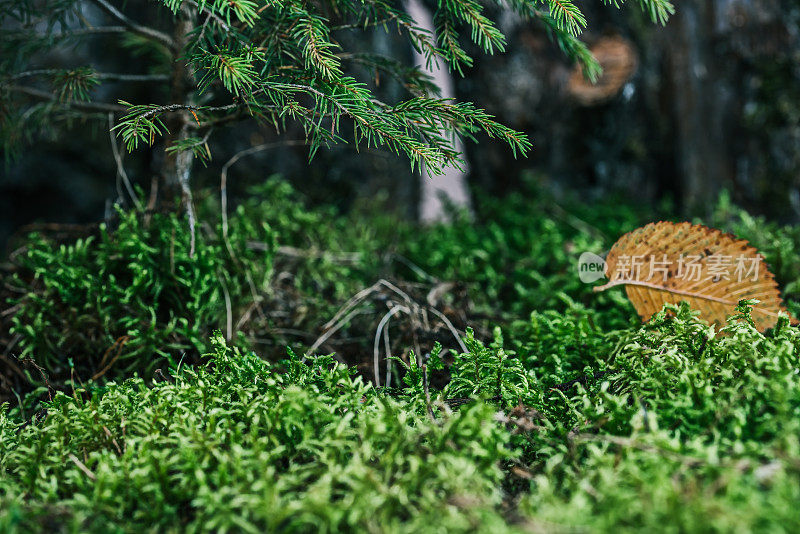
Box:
(0, 177, 800, 532)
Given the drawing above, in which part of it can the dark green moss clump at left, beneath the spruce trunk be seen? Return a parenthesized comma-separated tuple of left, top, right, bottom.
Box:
(5, 205, 273, 381)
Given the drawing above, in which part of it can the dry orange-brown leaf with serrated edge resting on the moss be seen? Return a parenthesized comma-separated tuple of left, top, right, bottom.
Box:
(595, 221, 797, 330)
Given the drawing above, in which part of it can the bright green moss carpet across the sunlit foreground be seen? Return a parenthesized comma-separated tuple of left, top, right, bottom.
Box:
(0, 303, 800, 532)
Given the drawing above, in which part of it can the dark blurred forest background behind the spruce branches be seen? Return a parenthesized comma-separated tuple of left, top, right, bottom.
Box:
(0, 0, 800, 250)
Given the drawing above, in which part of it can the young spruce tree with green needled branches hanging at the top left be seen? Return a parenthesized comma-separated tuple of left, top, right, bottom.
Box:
(0, 0, 673, 241)
